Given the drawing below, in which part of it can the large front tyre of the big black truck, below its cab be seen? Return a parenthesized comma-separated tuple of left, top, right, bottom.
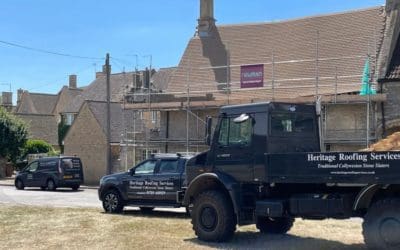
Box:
(191, 190, 236, 242)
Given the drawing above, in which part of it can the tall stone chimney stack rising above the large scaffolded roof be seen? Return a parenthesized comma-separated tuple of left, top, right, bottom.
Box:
(197, 0, 215, 37)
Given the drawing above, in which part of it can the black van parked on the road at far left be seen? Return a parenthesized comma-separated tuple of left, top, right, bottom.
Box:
(15, 156, 83, 191)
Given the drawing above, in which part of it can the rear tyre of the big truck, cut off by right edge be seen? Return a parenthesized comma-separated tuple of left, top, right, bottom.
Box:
(363, 199, 400, 249)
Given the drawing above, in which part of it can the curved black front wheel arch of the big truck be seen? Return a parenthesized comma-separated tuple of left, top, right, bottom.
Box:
(183, 173, 239, 214)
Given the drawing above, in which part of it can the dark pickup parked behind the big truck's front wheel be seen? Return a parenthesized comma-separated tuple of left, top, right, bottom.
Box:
(98, 154, 194, 213)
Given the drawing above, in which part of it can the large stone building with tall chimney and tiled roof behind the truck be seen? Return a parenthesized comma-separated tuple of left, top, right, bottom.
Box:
(126, 0, 400, 152)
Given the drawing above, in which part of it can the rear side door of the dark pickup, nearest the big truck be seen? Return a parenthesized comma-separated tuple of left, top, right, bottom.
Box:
(154, 159, 182, 204)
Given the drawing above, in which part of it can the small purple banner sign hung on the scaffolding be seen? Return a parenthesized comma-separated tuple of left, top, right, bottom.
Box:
(240, 64, 264, 88)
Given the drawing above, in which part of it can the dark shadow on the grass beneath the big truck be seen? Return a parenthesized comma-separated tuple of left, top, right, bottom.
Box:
(184, 232, 366, 250)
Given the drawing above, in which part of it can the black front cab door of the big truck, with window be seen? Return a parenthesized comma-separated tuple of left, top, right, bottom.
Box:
(214, 114, 254, 182)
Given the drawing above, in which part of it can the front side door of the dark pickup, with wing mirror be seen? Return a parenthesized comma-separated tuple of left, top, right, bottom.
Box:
(124, 160, 157, 200)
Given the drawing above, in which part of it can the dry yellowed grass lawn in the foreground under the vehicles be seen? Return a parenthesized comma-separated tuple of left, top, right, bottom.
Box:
(0, 204, 364, 250)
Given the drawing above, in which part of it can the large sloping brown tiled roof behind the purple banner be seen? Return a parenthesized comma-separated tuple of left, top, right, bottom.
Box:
(168, 7, 385, 99)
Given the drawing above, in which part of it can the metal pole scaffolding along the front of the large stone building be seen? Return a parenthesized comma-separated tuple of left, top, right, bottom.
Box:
(121, 32, 386, 165)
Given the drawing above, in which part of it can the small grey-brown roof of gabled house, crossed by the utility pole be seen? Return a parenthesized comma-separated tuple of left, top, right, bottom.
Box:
(87, 101, 140, 143)
